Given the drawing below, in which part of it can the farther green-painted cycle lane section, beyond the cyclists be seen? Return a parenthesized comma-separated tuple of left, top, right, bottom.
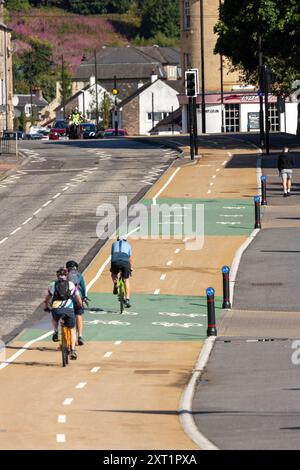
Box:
(136, 198, 254, 237)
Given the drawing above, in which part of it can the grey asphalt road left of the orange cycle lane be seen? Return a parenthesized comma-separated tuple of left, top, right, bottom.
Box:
(0, 139, 178, 341)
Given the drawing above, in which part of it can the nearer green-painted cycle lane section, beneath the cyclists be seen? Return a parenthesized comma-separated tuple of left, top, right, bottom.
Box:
(17, 293, 222, 341)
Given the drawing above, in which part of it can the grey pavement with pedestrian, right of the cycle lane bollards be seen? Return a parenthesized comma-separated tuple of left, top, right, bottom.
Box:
(193, 138, 300, 450)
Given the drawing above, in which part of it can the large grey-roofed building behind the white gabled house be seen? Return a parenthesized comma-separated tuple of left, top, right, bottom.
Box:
(72, 46, 181, 100)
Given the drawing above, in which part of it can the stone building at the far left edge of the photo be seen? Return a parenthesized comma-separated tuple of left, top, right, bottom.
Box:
(0, 0, 14, 133)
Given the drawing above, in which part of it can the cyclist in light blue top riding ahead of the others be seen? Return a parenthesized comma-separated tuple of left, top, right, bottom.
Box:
(110, 237, 132, 308)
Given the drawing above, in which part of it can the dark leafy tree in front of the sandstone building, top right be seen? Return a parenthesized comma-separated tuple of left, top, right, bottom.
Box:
(215, 0, 300, 95)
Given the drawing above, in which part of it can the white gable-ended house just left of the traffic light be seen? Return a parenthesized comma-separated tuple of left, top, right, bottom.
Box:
(118, 75, 181, 135)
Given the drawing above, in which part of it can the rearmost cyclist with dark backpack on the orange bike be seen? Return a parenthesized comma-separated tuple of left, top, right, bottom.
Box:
(44, 268, 82, 359)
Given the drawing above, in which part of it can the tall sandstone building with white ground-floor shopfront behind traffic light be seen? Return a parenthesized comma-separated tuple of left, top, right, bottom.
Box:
(179, 0, 298, 133)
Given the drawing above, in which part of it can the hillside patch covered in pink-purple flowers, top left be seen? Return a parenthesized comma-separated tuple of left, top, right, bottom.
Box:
(8, 8, 134, 70)
